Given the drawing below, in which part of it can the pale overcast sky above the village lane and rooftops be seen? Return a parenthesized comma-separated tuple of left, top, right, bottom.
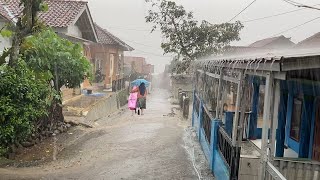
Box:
(88, 0, 320, 73)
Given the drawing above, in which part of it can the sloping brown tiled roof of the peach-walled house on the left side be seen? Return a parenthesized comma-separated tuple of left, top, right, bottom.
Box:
(94, 23, 134, 51)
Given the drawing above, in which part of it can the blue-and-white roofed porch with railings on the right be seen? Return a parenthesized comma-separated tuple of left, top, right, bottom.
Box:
(192, 48, 320, 179)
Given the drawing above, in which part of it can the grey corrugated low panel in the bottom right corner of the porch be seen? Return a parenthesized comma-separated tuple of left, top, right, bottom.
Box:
(273, 158, 320, 180)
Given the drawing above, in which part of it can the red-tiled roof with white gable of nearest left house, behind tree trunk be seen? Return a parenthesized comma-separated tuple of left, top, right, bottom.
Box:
(0, 0, 97, 42)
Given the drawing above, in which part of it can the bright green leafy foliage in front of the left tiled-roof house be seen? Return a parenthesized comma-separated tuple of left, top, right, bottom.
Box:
(22, 29, 91, 89)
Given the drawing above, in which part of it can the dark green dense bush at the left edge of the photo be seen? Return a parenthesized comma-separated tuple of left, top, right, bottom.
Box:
(0, 60, 49, 155)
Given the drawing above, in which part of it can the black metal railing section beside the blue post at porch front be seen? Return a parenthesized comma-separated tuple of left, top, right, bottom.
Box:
(218, 126, 241, 179)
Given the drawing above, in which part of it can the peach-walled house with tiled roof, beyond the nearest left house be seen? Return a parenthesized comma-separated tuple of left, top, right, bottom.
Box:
(90, 24, 134, 87)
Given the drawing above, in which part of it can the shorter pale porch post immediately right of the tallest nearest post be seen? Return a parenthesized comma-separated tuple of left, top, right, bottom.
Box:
(269, 80, 280, 160)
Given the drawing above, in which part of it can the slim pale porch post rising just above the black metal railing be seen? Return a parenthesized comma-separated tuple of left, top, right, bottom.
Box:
(232, 72, 243, 146)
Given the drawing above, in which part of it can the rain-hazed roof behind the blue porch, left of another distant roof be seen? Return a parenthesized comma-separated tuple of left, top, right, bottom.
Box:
(224, 35, 295, 55)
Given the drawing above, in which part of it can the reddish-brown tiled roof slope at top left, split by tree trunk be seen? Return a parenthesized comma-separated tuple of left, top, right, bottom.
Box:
(0, 0, 87, 27)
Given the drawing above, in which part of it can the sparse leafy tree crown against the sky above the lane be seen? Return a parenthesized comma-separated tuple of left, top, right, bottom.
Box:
(146, 0, 243, 71)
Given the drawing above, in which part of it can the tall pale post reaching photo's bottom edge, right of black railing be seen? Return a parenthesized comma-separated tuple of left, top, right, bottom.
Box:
(259, 73, 272, 180)
